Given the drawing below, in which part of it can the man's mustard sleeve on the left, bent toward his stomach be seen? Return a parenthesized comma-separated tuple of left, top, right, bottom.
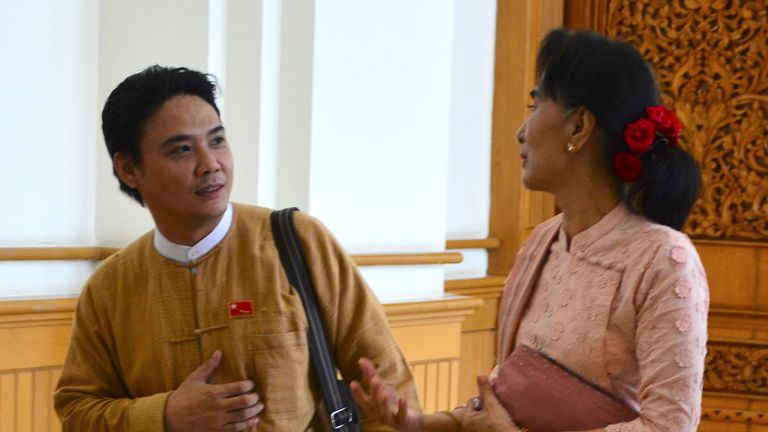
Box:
(53, 286, 169, 432)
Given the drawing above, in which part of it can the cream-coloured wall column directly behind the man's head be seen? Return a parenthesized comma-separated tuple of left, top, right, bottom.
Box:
(95, 0, 216, 247)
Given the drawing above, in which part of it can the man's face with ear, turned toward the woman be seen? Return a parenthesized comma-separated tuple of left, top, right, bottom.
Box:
(114, 95, 233, 244)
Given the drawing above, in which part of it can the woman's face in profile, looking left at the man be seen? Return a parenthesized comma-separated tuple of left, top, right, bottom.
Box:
(517, 89, 571, 193)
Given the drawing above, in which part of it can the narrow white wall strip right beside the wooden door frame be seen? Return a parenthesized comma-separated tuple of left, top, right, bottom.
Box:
(446, 0, 496, 279)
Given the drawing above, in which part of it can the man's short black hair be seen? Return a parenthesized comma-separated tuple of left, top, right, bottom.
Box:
(101, 65, 219, 205)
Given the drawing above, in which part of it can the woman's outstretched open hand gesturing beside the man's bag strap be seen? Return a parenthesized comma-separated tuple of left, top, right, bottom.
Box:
(349, 358, 423, 432)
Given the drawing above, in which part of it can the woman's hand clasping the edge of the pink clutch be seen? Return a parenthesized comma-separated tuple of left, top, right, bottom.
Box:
(462, 376, 520, 432)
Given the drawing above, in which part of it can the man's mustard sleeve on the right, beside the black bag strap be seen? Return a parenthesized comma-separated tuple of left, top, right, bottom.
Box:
(296, 213, 419, 431)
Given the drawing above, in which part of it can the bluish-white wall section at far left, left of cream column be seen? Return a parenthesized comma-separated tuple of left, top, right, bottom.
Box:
(0, 0, 98, 298)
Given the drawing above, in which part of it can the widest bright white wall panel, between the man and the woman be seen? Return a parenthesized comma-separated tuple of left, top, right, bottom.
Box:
(309, 0, 453, 299)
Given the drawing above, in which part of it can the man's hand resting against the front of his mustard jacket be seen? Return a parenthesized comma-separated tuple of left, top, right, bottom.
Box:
(165, 350, 264, 432)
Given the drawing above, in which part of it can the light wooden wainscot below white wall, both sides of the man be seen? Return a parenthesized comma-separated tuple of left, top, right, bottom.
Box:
(0, 296, 483, 432)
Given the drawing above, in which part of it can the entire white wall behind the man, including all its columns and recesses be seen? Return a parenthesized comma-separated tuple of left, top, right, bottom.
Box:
(0, 0, 495, 300)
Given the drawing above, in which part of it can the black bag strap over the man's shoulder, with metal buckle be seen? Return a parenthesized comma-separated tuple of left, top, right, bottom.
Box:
(270, 207, 359, 432)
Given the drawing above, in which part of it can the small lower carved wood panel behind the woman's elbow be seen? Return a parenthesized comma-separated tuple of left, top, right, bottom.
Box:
(704, 341, 768, 395)
